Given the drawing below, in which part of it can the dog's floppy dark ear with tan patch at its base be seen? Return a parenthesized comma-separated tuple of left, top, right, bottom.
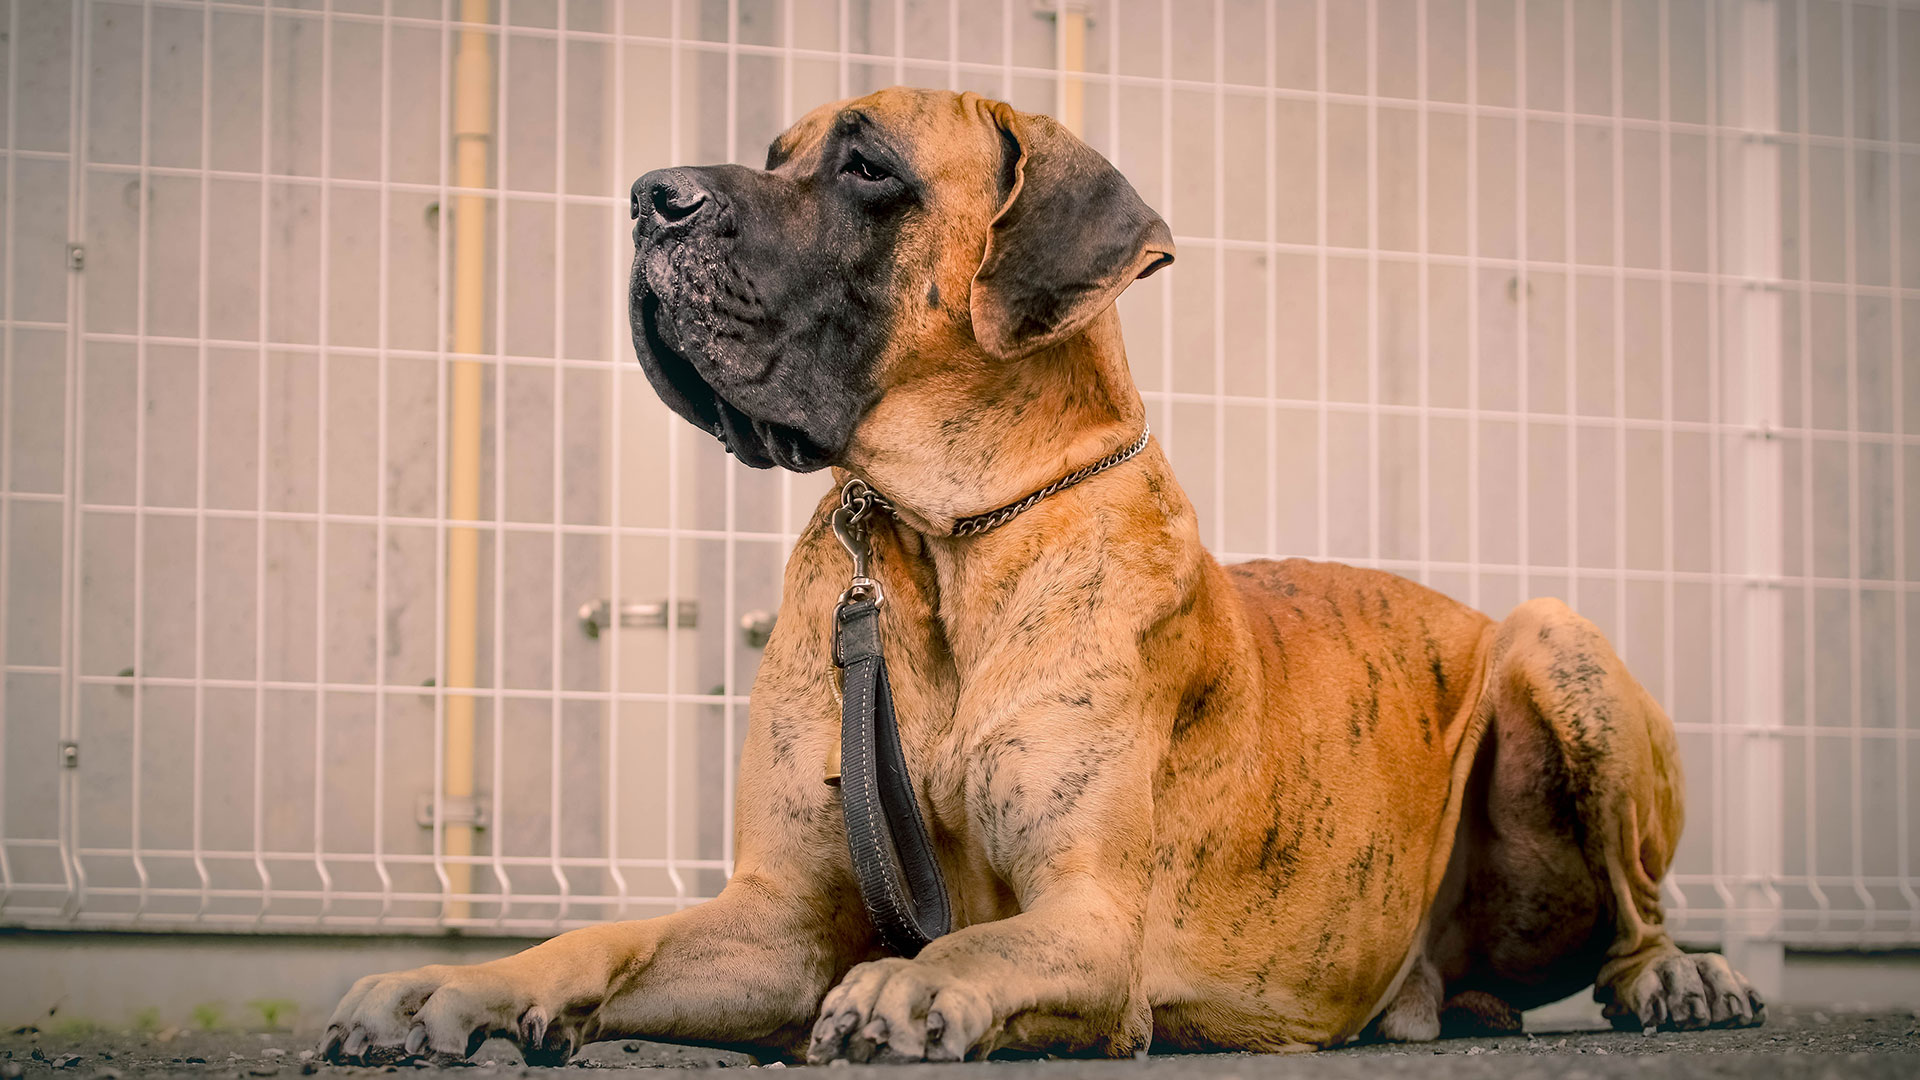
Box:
(970, 102, 1173, 359)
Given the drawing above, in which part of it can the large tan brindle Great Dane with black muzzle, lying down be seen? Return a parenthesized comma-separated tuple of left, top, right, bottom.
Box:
(323, 88, 1763, 1063)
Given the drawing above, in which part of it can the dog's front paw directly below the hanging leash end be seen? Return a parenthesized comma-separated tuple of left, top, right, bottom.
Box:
(806, 959, 996, 1065)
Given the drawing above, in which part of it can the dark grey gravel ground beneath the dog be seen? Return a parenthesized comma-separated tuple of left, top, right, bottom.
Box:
(0, 1007, 1920, 1080)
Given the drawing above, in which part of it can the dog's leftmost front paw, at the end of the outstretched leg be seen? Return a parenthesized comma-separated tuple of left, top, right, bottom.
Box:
(321, 965, 584, 1065)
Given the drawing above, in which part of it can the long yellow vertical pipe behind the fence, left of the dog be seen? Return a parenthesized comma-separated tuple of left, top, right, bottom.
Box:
(442, 0, 487, 919)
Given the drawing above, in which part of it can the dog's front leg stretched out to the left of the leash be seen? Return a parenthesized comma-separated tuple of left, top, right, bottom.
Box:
(323, 502, 879, 1061)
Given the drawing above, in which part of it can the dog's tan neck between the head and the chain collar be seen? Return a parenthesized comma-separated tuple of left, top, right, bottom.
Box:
(841, 307, 1146, 536)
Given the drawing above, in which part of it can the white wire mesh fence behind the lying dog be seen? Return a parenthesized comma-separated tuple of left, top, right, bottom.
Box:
(0, 0, 1920, 947)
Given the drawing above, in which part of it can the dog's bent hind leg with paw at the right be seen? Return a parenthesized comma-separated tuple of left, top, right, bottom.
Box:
(1438, 600, 1764, 1028)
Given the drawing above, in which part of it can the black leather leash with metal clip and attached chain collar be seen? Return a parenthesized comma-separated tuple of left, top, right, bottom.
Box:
(828, 429, 1148, 957)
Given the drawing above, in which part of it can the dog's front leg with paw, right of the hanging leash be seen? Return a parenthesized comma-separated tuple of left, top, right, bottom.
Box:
(806, 663, 1158, 1063)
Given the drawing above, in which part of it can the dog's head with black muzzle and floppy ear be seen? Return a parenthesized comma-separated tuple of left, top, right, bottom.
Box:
(628, 88, 1173, 471)
